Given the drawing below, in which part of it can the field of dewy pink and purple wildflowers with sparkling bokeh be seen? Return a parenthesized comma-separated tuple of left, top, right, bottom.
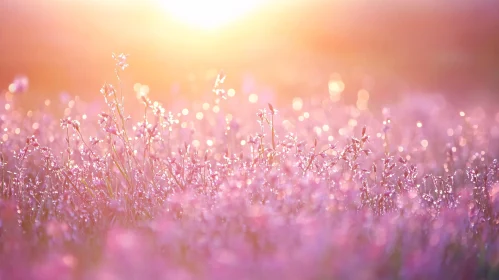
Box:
(0, 55, 499, 280)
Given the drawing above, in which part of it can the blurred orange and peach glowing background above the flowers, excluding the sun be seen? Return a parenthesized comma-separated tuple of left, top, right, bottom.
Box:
(0, 0, 499, 110)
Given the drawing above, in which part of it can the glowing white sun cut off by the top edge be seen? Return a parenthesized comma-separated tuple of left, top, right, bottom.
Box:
(161, 0, 263, 29)
